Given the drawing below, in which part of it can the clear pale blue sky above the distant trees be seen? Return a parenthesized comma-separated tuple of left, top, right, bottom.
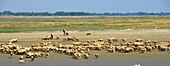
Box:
(0, 0, 170, 13)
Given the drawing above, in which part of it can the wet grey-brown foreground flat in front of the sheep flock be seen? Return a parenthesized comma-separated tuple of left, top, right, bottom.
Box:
(0, 52, 170, 66)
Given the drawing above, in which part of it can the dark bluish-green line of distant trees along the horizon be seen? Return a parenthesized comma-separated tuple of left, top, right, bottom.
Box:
(0, 11, 170, 16)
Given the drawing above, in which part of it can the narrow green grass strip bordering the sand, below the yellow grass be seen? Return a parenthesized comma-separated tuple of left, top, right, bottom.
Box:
(0, 25, 170, 33)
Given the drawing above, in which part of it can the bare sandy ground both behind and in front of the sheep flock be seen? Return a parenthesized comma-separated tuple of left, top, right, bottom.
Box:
(0, 30, 170, 66)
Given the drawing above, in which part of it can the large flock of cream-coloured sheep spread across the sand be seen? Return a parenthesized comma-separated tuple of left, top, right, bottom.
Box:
(0, 33, 170, 66)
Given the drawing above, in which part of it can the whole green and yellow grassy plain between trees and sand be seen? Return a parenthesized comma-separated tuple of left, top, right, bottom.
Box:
(0, 16, 170, 33)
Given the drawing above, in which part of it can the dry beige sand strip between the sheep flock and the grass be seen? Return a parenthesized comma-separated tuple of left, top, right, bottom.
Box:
(0, 29, 170, 46)
